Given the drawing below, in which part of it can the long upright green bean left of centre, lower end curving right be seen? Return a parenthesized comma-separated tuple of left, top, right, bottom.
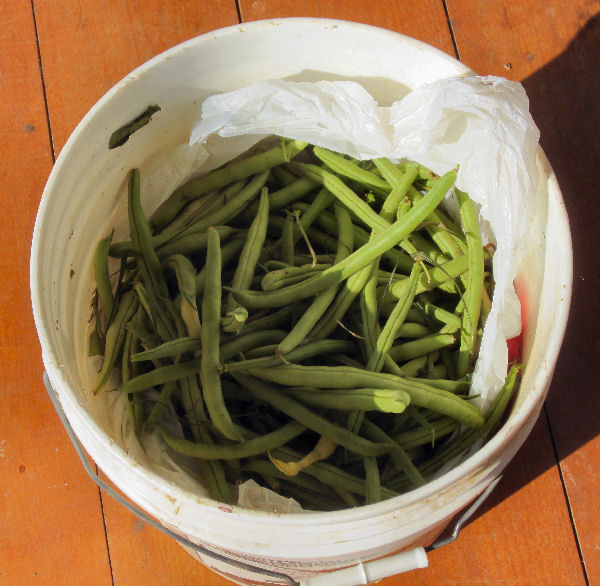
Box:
(201, 228, 244, 441)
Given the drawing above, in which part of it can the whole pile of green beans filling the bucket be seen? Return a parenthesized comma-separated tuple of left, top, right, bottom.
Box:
(90, 139, 517, 510)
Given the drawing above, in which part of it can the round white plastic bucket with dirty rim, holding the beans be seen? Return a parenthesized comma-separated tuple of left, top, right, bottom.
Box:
(31, 19, 572, 583)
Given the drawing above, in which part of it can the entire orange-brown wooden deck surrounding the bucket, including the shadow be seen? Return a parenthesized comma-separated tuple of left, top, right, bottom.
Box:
(0, 0, 600, 586)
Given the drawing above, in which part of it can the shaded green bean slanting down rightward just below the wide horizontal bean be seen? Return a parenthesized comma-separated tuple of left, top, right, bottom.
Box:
(234, 373, 388, 456)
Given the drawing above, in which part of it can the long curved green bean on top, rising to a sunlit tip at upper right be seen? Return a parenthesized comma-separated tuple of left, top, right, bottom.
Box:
(233, 171, 456, 308)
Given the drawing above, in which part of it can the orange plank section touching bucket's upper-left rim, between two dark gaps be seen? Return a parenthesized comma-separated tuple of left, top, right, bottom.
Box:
(34, 0, 238, 154)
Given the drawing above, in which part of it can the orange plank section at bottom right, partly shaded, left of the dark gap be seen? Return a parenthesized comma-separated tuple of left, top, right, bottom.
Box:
(394, 416, 585, 586)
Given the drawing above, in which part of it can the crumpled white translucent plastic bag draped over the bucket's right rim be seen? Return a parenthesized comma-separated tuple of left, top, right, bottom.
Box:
(190, 75, 539, 410)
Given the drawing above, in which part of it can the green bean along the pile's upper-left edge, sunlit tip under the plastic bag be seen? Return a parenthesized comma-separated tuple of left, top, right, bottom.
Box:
(152, 141, 307, 229)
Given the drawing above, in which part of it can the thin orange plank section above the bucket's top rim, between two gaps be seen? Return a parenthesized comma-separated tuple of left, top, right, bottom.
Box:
(239, 0, 455, 57)
